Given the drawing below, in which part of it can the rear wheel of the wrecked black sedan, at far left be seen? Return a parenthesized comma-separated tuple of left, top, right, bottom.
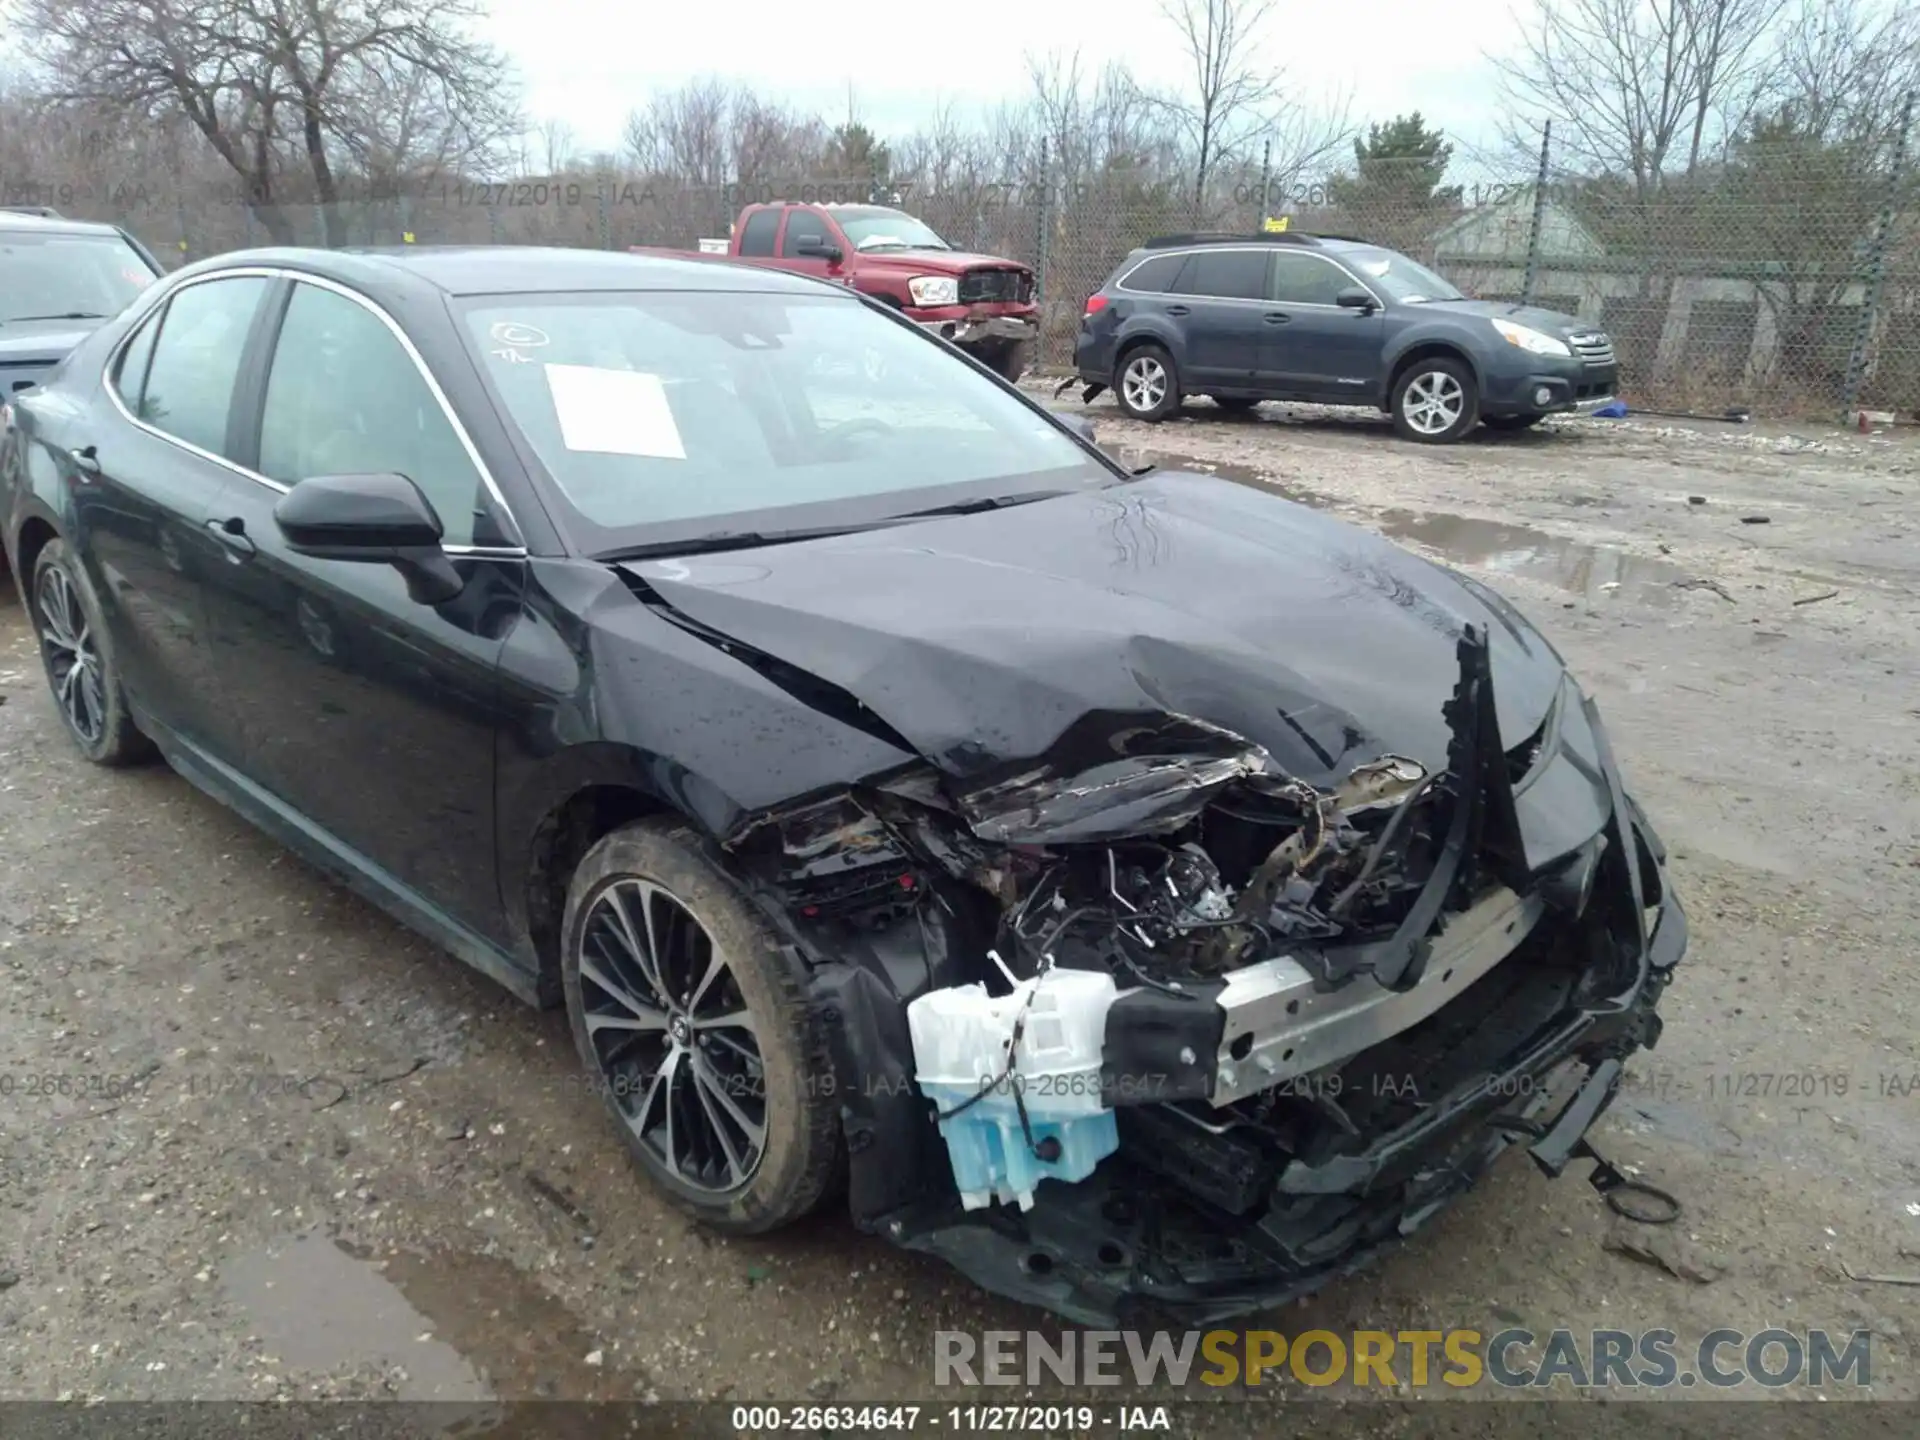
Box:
(27, 540, 154, 768)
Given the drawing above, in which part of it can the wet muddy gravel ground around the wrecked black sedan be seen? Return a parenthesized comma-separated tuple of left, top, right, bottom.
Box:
(0, 401, 1920, 1434)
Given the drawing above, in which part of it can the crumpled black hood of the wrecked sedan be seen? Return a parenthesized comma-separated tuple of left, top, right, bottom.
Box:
(626, 472, 1563, 802)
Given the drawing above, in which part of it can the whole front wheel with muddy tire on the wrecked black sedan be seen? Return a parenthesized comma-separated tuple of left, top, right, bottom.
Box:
(561, 820, 845, 1235)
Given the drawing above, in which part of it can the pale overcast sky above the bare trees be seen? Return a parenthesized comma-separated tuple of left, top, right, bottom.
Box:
(492, 0, 1526, 170)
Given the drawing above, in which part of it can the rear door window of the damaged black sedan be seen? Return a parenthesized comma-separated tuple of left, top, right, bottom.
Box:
(135, 275, 267, 455)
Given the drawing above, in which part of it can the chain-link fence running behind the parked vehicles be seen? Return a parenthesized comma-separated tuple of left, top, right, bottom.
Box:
(18, 106, 1920, 417)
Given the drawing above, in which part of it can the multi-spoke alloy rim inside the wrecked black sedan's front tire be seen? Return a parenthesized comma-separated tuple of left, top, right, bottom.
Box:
(580, 877, 766, 1194)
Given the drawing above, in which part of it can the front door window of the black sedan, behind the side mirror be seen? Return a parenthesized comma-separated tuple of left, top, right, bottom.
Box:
(259, 284, 484, 545)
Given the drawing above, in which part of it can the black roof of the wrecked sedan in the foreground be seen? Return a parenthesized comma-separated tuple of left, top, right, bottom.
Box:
(190, 246, 847, 296)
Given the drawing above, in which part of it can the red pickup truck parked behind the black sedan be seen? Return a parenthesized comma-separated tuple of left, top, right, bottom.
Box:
(634, 200, 1039, 380)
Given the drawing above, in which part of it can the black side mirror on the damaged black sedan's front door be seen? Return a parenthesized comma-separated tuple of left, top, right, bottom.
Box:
(273, 474, 467, 605)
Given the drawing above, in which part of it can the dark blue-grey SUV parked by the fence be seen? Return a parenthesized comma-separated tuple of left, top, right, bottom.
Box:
(1073, 232, 1619, 444)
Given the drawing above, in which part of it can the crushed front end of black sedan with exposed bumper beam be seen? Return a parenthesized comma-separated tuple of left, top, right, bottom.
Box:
(730, 626, 1686, 1325)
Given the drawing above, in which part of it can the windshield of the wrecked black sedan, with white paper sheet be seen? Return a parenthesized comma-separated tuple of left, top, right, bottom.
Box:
(465, 292, 1119, 555)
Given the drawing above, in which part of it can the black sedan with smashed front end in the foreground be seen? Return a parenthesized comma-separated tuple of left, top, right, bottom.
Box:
(0, 250, 1686, 1323)
